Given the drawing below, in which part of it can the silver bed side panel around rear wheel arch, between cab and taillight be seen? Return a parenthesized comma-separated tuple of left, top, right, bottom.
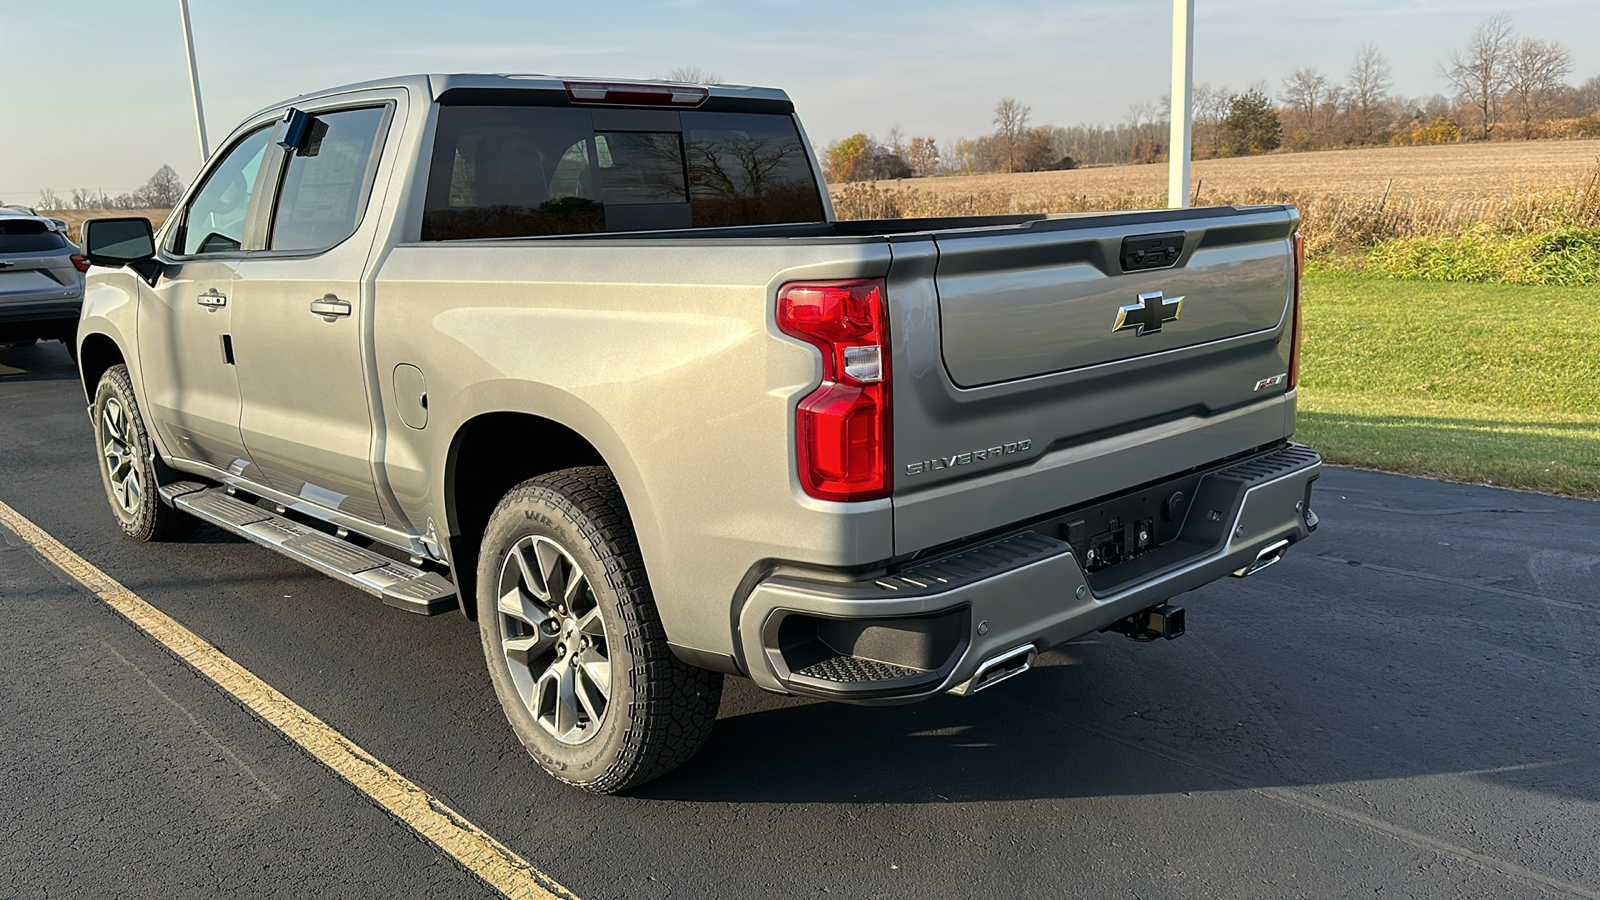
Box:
(374, 239, 893, 653)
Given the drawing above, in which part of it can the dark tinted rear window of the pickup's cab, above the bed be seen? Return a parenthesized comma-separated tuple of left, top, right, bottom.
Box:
(422, 106, 822, 240)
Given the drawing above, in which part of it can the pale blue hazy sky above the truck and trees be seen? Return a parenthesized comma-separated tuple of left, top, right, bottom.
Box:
(0, 0, 1600, 203)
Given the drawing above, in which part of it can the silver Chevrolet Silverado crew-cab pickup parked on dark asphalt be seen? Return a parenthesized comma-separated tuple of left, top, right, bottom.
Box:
(78, 75, 1320, 791)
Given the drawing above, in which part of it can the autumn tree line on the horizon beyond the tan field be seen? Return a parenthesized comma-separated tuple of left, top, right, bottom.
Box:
(822, 13, 1600, 181)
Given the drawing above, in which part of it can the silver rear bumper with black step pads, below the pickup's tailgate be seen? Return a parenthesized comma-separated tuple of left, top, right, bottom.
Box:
(739, 444, 1322, 705)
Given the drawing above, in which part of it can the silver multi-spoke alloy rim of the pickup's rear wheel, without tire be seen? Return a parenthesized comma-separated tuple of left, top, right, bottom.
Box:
(499, 535, 611, 745)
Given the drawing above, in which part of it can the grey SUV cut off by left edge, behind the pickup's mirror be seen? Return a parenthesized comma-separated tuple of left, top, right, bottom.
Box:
(0, 215, 90, 359)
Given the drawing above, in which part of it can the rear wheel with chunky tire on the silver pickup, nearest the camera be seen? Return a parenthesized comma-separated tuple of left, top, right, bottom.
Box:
(477, 466, 722, 794)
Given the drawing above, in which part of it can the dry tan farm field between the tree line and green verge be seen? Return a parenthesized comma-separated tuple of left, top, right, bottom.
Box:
(830, 141, 1600, 258)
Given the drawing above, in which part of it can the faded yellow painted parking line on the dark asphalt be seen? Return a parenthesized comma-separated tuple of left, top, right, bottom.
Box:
(0, 503, 578, 900)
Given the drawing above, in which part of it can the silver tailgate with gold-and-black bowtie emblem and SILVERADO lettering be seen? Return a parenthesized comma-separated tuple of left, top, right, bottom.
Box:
(888, 207, 1299, 552)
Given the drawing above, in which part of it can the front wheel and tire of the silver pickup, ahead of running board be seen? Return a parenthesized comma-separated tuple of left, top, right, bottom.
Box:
(94, 365, 198, 541)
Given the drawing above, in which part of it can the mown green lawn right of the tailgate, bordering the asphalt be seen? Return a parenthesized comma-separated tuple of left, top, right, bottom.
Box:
(1296, 274, 1600, 498)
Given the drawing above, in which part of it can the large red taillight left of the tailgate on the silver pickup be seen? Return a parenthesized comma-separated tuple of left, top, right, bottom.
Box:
(778, 279, 890, 500)
